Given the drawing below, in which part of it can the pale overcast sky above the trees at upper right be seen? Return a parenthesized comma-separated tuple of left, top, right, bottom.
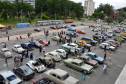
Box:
(71, 0, 126, 9)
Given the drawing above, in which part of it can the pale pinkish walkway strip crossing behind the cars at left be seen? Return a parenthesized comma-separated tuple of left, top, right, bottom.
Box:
(0, 29, 65, 43)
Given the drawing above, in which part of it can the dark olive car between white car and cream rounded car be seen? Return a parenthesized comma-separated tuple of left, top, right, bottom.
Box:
(36, 57, 55, 68)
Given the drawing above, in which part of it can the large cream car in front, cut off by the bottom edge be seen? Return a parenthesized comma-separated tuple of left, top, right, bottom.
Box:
(45, 69, 79, 84)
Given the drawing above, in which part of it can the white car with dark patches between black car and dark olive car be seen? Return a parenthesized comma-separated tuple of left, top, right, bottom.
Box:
(26, 60, 46, 72)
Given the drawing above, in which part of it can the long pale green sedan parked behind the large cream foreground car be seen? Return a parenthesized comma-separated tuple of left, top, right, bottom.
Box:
(63, 58, 93, 74)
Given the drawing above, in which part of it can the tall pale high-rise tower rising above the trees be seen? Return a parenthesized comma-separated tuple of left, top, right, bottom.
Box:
(84, 0, 95, 16)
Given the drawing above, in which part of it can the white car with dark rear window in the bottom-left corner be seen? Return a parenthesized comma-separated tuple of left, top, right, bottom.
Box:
(0, 71, 23, 84)
